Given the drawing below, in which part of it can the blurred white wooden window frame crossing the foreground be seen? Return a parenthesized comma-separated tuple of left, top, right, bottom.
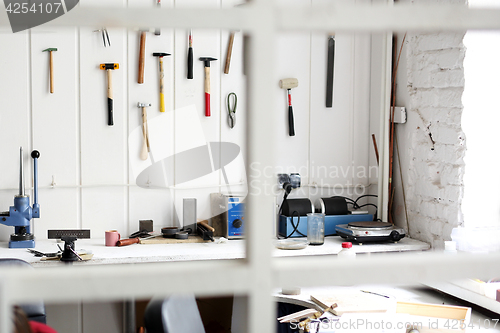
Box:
(0, 0, 500, 332)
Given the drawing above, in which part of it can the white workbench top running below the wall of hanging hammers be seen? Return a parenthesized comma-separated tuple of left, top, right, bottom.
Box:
(0, 236, 430, 267)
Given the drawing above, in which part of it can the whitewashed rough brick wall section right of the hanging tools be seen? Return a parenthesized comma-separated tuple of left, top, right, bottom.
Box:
(393, 0, 466, 248)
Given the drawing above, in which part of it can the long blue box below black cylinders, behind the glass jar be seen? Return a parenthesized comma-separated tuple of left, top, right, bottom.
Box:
(278, 214, 373, 237)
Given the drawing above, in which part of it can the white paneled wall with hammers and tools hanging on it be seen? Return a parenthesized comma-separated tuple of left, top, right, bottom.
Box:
(0, 0, 381, 246)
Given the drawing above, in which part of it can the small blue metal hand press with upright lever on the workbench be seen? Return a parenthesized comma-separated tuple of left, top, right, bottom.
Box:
(0, 147, 40, 248)
